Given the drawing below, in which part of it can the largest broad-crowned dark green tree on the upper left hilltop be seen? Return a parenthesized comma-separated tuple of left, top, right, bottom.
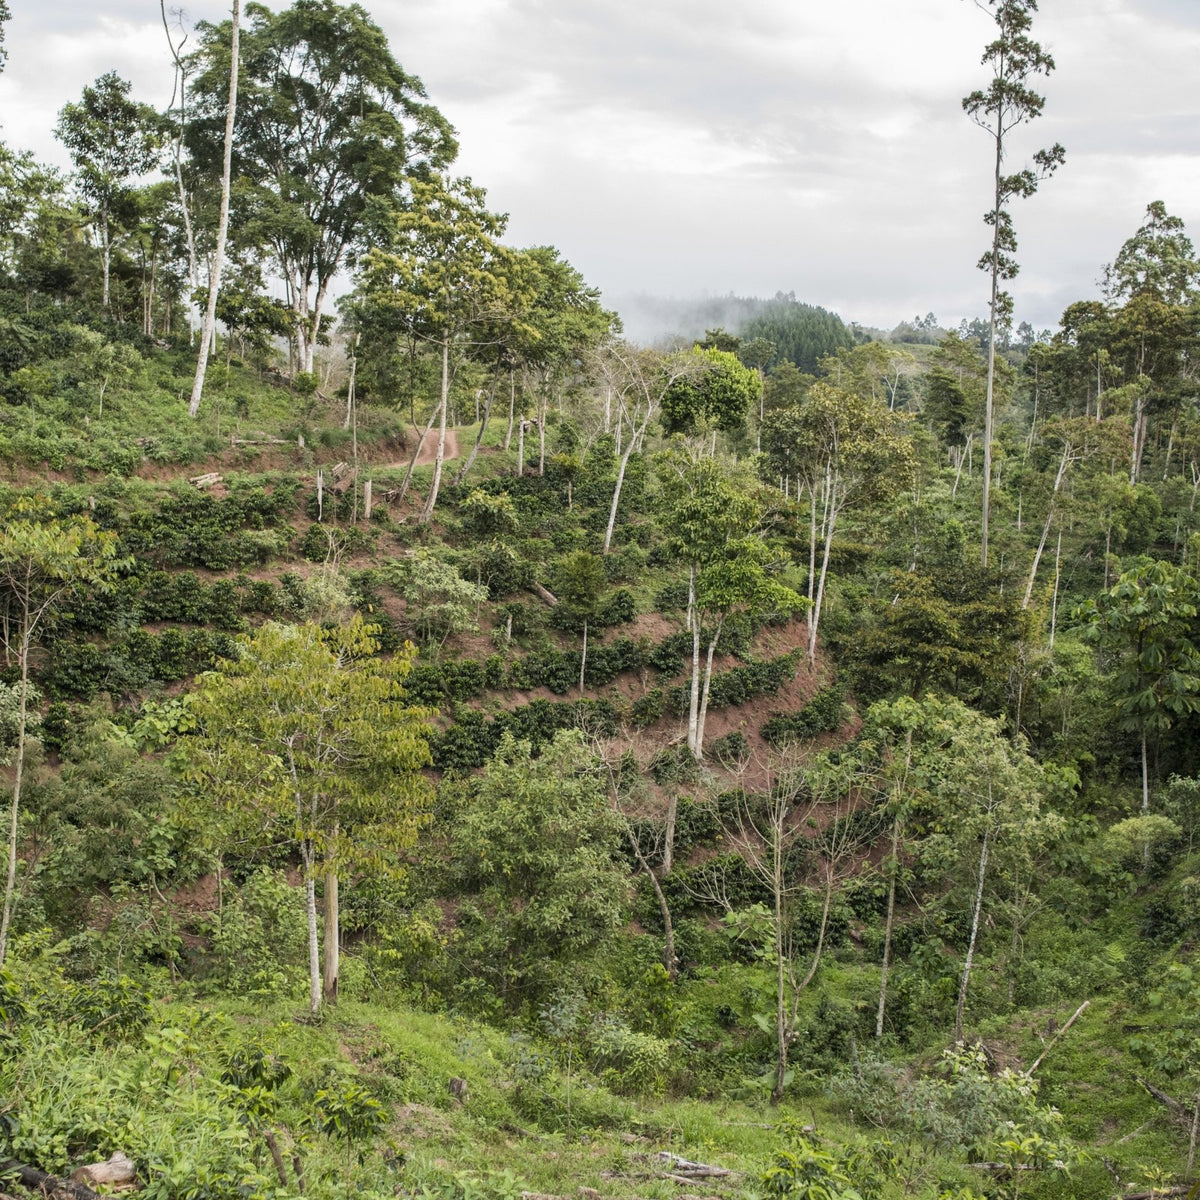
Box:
(188, 0, 457, 371)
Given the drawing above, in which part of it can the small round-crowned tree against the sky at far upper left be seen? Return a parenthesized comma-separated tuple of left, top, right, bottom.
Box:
(54, 71, 162, 310)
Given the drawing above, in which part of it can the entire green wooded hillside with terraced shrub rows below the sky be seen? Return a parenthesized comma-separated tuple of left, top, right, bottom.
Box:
(0, 0, 1200, 1200)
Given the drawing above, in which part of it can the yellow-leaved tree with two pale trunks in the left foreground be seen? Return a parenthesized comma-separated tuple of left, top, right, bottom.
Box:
(184, 617, 430, 1013)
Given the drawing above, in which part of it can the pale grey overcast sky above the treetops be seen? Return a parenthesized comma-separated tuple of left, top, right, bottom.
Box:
(0, 0, 1200, 338)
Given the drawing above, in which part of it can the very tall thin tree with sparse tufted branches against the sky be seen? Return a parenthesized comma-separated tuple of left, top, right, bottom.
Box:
(962, 0, 1066, 566)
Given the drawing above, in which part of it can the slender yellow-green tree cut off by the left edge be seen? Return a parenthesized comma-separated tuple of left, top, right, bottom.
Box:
(0, 499, 116, 966)
